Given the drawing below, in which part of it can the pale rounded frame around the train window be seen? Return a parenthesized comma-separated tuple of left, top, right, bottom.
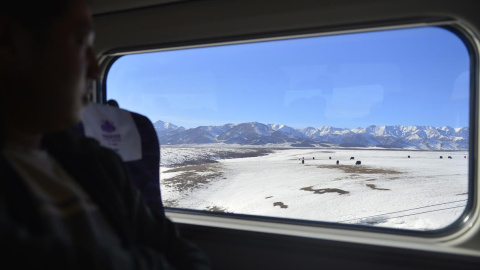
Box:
(96, 17, 480, 243)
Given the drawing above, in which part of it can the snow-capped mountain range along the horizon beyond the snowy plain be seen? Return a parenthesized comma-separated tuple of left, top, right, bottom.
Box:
(154, 120, 469, 150)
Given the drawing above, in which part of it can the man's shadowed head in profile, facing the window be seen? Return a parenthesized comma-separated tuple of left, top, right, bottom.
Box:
(0, 0, 98, 134)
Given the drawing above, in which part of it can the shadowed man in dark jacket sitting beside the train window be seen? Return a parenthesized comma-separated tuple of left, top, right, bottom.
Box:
(0, 0, 210, 269)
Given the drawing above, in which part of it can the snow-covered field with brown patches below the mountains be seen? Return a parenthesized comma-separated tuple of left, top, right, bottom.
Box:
(160, 148, 468, 230)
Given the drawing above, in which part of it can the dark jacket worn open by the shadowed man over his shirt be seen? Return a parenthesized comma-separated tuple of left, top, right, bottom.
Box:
(0, 131, 210, 269)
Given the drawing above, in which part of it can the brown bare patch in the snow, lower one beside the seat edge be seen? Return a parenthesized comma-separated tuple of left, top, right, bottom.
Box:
(162, 164, 223, 191)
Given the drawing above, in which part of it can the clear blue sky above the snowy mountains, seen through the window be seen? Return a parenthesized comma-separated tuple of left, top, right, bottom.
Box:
(107, 27, 470, 128)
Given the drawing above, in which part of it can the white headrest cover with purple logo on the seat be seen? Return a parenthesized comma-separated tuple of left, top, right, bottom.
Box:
(82, 102, 142, 161)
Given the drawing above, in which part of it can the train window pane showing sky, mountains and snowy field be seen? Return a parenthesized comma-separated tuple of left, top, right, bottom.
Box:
(106, 26, 474, 231)
